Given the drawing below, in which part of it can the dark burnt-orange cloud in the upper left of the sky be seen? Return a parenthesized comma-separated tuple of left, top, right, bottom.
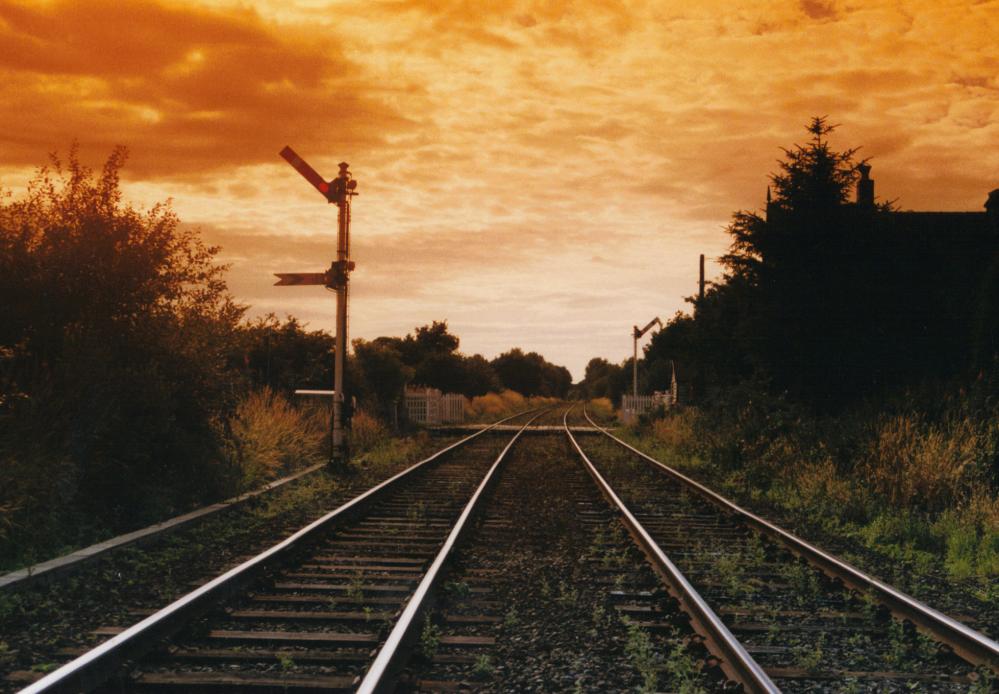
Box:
(0, 0, 411, 177)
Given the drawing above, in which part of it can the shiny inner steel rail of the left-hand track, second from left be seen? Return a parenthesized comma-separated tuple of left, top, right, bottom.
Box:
(356, 412, 546, 694)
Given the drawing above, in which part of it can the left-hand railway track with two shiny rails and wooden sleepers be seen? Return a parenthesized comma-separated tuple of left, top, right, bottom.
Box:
(17, 413, 537, 693)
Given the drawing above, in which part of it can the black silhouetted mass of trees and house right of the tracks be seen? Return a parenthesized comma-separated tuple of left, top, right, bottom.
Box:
(620, 118, 999, 411)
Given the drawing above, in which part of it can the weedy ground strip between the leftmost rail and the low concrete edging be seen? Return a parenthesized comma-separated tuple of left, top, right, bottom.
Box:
(0, 433, 454, 691)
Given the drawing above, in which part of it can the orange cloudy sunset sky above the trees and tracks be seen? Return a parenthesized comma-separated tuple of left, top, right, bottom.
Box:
(0, 0, 999, 379)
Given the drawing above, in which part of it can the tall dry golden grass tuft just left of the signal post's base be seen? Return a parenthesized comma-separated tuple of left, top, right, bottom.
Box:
(227, 387, 326, 490)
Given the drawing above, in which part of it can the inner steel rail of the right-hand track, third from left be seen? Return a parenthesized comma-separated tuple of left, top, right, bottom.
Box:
(563, 410, 781, 694)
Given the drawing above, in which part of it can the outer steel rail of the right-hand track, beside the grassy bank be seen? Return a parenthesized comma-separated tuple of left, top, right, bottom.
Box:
(583, 407, 999, 673)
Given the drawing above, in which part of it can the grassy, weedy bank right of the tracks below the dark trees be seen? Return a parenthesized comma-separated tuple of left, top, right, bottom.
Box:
(625, 388, 999, 584)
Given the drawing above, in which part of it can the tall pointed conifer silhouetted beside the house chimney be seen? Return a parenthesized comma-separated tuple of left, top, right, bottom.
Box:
(716, 118, 877, 404)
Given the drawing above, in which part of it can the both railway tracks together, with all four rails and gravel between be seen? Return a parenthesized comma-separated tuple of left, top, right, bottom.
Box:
(15, 409, 999, 692)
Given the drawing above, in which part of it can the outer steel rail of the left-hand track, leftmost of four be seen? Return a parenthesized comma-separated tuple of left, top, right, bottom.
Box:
(20, 409, 537, 694)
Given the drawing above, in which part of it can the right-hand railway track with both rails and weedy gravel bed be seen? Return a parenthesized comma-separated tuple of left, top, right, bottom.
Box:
(566, 406, 999, 692)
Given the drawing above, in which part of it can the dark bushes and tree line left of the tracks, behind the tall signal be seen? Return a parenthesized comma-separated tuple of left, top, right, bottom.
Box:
(0, 149, 570, 566)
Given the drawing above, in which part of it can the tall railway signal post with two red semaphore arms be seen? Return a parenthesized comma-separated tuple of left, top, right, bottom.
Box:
(274, 147, 357, 465)
